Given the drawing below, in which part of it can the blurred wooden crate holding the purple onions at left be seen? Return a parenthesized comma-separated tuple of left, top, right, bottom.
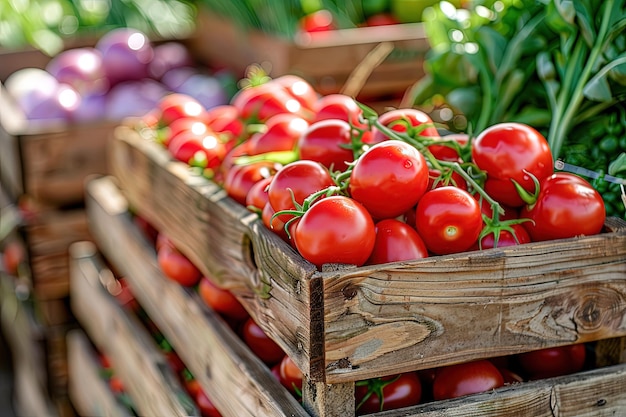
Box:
(0, 84, 119, 207)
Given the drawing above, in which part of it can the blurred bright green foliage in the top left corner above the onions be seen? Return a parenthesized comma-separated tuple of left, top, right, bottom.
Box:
(0, 0, 196, 56)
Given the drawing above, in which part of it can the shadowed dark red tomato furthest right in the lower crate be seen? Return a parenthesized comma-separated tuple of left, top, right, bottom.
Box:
(518, 343, 587, 379)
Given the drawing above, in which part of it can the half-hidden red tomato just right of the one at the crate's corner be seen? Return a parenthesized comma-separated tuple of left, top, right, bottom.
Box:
(367, 219, 428, 265)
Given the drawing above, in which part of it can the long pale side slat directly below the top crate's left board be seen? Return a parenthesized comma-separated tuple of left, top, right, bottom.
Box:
(81, 178, 307, 417)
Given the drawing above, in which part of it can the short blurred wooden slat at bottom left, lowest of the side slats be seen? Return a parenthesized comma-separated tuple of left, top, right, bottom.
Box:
(67, 329, 132, 417)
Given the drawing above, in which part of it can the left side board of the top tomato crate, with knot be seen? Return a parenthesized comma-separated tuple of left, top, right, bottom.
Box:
(110, 127, 323, 374)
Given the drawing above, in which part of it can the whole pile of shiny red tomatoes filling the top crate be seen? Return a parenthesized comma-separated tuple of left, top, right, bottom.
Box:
(142, 68, 605, 269)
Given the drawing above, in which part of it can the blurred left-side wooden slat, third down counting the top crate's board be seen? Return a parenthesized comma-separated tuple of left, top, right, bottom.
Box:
(70, 242, 199, 416)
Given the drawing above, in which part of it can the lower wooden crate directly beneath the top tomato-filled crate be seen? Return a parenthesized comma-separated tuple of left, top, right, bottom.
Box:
(85, 178, 626, 417)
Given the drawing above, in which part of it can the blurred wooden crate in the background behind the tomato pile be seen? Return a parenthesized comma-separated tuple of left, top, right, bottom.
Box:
(188, 8, 430, 98)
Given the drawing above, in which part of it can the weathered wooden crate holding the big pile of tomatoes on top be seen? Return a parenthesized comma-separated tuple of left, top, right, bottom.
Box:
(106, 127, 626, 383)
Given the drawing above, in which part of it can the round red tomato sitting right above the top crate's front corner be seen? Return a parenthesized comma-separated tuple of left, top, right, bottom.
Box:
(293, 196, 376, 268)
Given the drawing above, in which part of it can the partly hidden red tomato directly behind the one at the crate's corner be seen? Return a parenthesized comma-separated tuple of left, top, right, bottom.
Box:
(267, 160, 335, 211)
